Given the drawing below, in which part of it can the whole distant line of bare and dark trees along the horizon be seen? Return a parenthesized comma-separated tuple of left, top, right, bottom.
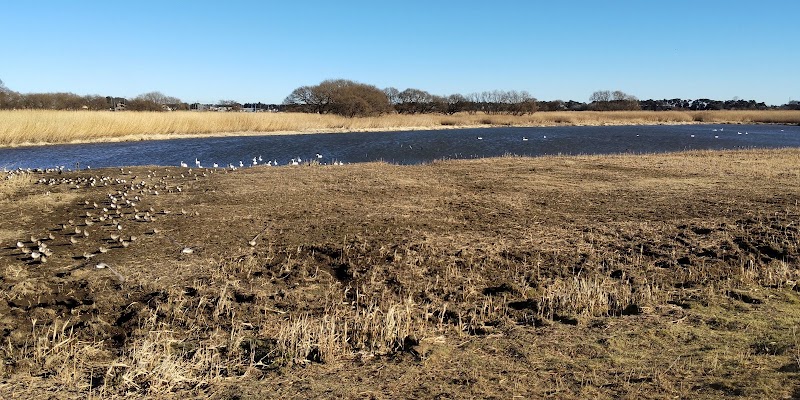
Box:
(0, 79, 800, 117)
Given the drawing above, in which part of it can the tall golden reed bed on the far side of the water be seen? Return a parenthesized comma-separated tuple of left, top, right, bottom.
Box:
(0, 110, 800, 146)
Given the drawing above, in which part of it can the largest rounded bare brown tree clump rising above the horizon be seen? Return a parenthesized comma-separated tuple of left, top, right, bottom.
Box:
(283, 79, 392, 117)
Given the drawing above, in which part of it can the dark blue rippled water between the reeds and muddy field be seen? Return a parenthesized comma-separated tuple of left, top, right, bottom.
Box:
(0, 125, 800, 169)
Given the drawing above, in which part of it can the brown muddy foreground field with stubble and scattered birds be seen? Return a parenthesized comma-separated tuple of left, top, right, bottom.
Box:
(0, 150, 800, 399)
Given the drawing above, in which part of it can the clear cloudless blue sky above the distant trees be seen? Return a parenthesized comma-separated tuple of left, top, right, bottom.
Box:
(0, 0, 800, 104)
